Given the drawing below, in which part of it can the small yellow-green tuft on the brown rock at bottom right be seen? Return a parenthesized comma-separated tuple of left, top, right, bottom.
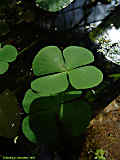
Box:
(94, 149, 106, 160)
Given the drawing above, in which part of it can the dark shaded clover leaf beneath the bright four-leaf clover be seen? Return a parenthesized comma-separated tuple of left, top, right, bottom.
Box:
(22, 91, 91, 145)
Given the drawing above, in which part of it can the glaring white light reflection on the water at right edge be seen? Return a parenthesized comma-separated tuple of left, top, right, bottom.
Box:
(96, 24, 120, 65)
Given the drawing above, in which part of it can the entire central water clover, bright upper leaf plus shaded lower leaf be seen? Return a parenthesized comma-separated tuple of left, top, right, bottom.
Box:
(22, 46, 103, 144)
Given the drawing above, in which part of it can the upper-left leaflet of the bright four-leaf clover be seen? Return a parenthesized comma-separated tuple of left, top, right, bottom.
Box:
(32, 46, 65, 76)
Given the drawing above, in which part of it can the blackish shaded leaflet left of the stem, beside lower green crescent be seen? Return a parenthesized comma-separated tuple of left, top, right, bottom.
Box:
(30, 111, 58, 145)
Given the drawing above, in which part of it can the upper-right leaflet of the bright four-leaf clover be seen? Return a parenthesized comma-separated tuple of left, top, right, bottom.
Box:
(63, 46, 94, 70)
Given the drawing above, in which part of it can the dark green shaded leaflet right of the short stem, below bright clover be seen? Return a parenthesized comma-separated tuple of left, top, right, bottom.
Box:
(62, 100, 92, 137)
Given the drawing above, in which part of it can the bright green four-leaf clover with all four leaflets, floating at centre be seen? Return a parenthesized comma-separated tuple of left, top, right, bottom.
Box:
(31, 46, 103, 96)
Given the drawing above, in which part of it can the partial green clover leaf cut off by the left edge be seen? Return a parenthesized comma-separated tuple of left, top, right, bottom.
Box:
(0, 45, 17, 75)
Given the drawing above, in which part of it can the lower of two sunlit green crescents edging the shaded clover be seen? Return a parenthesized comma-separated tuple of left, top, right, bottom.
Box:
(22, 116, 37, 143)
